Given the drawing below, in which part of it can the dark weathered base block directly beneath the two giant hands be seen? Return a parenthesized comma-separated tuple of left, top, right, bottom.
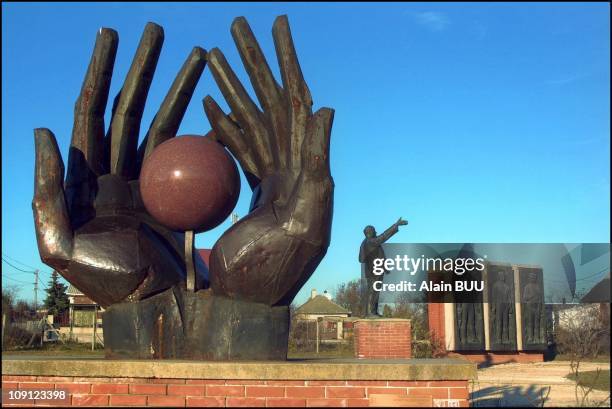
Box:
(103, 287, 289, 361)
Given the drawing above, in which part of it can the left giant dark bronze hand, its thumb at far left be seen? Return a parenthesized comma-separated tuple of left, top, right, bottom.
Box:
(32, 23, 205, 306)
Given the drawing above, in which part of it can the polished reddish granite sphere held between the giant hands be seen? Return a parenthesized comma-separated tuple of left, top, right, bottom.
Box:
(140, 135, 240, 232)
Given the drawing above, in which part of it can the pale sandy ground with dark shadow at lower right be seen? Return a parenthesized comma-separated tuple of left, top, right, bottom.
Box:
(471, 361, 610, 407)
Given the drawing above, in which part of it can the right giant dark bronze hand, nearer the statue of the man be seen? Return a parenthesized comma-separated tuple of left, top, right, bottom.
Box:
(204, 16, 334, 305)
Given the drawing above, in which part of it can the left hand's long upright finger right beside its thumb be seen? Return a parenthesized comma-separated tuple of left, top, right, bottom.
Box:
(66, 28, 119, 223)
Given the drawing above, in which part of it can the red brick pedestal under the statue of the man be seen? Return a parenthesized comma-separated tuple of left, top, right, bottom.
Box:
(355, 318, 412, 359)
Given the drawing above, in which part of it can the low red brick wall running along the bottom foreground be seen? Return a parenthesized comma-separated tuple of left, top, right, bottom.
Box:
(2, 375, 468, 407)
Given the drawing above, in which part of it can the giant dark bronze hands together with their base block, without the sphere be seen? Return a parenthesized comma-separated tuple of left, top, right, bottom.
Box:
(32, 16, 334, 359)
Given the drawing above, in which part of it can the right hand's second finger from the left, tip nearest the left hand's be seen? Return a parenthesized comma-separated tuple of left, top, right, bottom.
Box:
(208, 48, 277, 174)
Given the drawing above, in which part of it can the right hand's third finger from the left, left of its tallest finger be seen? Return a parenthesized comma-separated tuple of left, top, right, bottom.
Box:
(231, 17, 289, 167)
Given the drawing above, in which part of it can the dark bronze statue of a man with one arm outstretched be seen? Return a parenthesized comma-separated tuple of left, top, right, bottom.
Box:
(359, 217, 408, 317)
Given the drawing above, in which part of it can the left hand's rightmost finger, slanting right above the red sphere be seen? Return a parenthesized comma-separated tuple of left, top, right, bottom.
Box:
(138, 47, 206, 162)
